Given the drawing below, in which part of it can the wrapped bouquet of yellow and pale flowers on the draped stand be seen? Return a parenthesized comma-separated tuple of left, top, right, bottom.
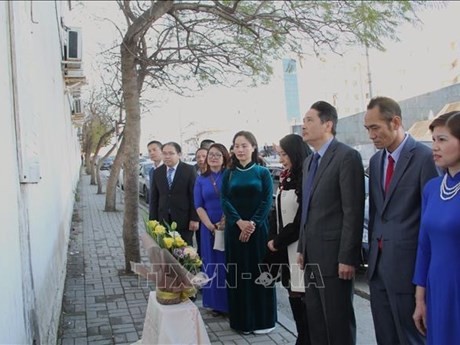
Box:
(132, 220, 209, 304)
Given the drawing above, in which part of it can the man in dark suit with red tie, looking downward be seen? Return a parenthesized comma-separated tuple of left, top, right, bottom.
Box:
(364, 97, 437, 345)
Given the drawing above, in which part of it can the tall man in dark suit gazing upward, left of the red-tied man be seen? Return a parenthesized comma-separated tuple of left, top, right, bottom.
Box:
(297, 101, 364, 345)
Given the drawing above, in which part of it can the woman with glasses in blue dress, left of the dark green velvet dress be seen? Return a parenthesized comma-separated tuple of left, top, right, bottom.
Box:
(194, 144, 230, 314)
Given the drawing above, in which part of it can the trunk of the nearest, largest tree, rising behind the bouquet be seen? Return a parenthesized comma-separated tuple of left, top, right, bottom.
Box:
(121, 38, 141, 272)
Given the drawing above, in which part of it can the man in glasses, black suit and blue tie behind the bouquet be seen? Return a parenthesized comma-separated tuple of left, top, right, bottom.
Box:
(149, 142, 199, 245)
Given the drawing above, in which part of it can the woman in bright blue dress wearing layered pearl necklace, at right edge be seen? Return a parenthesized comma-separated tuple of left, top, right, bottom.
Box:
(413, 112, 460, 345)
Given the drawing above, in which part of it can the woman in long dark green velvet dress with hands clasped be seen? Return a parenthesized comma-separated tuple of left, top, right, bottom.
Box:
(222, 131, 276, 334)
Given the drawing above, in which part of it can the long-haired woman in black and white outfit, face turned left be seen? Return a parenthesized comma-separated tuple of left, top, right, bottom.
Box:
(267, 134, 311, 345)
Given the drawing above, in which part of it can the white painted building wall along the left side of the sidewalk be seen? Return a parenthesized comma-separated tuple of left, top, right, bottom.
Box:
(0, 1, 80, 344)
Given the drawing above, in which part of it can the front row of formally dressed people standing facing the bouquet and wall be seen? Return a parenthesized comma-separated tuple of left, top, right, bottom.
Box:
(150, 97, 460, 344)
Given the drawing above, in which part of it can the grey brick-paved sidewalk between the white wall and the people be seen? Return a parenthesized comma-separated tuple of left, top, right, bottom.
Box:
(58, 175, 295, 345)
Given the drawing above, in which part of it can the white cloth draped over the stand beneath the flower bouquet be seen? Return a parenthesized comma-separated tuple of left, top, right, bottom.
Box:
(142, 291, 210, 344)
